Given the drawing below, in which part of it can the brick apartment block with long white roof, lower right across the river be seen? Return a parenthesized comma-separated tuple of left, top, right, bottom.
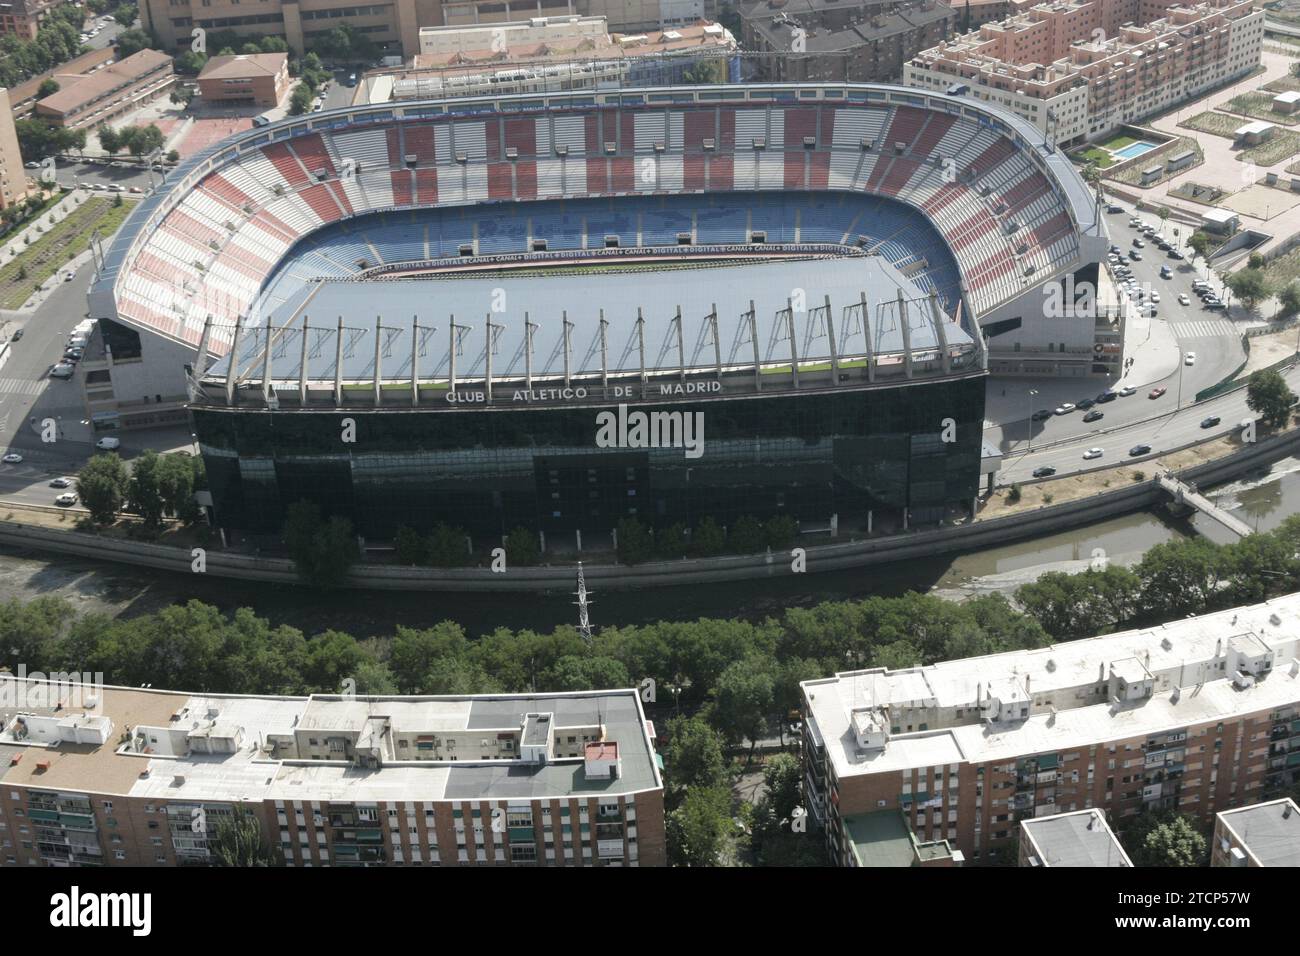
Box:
(802, 593, 1300, 865)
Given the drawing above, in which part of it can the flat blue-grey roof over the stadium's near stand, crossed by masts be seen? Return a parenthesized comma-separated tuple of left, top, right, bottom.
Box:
(208, 256, 972, 390)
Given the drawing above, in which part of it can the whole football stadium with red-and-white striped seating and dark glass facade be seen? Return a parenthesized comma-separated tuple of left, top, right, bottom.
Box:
(86, 85, 1106, 540)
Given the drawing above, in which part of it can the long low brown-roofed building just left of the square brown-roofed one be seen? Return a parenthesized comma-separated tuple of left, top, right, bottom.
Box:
(36, 49, 176, 129)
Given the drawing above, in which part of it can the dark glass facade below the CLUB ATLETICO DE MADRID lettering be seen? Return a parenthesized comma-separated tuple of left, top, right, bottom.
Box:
(191, 375, 984, 538)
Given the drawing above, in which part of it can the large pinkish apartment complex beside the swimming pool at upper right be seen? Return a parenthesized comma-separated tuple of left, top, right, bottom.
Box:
(902, 0, 1264, 146)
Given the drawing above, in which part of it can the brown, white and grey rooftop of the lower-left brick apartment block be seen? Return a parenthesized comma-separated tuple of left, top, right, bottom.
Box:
(0, 675, 662, 803)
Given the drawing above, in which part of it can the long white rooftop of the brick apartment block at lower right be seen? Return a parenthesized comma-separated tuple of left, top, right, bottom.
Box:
(802, 594, 1300, 778)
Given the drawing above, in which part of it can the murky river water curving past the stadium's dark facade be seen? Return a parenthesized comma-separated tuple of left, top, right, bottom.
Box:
(0, 458, 1300, 637)
